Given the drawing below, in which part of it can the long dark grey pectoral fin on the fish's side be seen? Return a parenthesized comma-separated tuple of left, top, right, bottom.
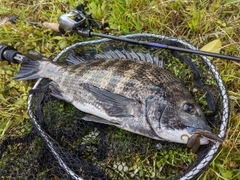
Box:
(81, 84, 138, 117)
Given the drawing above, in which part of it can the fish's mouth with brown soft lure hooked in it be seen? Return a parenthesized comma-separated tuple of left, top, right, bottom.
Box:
(187, 127, 223, 152)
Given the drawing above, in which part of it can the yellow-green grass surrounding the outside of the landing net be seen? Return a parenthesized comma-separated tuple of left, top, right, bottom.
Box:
(0, 0, 240, 180)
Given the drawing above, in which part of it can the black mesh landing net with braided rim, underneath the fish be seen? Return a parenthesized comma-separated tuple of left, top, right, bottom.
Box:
(0, 34, 228, 179)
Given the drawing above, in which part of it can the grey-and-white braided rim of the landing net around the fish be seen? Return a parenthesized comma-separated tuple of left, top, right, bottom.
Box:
(28, 33, 229, 180)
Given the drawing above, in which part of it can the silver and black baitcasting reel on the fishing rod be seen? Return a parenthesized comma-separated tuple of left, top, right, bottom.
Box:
(58, 4, 104, 32)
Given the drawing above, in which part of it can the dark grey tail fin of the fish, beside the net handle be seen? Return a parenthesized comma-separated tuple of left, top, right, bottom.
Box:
(13, 59, 41, 80)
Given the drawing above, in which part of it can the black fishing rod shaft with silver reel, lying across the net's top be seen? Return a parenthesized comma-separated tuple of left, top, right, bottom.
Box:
(58, 4, 240, 62)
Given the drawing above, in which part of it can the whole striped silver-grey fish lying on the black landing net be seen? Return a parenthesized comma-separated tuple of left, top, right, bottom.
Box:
(14, 51, 221, 150)
